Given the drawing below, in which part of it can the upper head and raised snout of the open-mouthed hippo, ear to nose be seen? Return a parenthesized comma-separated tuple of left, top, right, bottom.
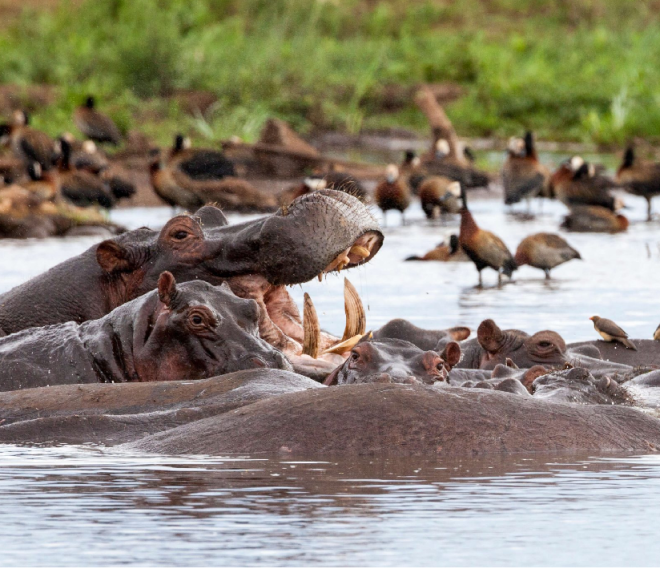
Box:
(96, 190, 383, 292)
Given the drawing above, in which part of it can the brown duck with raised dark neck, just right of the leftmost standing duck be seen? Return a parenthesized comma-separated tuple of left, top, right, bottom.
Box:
(58, 139, 117, 209)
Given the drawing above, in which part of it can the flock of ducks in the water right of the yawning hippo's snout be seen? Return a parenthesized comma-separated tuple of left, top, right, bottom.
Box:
(374, 132, 660, 286)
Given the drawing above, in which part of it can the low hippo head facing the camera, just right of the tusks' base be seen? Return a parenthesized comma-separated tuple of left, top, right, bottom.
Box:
(325, 337, 461, 386)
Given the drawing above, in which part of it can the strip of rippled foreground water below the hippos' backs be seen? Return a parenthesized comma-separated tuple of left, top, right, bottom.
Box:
(0, 446, 660, 565)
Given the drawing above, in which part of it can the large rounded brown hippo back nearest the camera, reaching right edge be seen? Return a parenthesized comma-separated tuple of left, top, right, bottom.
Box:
(125, 383, 660, 456)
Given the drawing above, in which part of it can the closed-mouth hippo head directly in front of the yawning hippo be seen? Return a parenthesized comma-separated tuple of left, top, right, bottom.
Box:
(126, 272, 291, 381)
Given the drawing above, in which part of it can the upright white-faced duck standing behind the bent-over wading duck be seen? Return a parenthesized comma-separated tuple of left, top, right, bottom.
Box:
(502, 131, 550, 209)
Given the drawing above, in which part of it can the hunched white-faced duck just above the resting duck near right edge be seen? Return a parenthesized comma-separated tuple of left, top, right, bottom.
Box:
(550, 156, 624, 211)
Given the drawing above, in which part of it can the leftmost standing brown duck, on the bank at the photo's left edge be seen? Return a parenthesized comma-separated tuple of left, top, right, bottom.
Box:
(0, 110, 61, 170)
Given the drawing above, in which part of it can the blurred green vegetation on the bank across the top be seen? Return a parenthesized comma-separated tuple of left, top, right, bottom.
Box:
(0, 0, 660, 144)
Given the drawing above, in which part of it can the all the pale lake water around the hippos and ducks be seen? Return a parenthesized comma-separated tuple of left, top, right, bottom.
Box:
(0, 196, 660, 566)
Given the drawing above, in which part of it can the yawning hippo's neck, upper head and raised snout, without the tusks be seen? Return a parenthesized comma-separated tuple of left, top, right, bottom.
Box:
(0, 190, 383, 348)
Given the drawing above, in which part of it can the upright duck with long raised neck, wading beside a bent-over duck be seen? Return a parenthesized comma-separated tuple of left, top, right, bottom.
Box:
(458, 185, 518, 286)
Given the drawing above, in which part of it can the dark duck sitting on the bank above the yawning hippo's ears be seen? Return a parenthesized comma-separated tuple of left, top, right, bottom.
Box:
(167, 134, 236, 180)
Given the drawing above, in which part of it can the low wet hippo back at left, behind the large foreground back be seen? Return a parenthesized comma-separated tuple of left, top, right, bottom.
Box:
(0, 369, 318, 445)
